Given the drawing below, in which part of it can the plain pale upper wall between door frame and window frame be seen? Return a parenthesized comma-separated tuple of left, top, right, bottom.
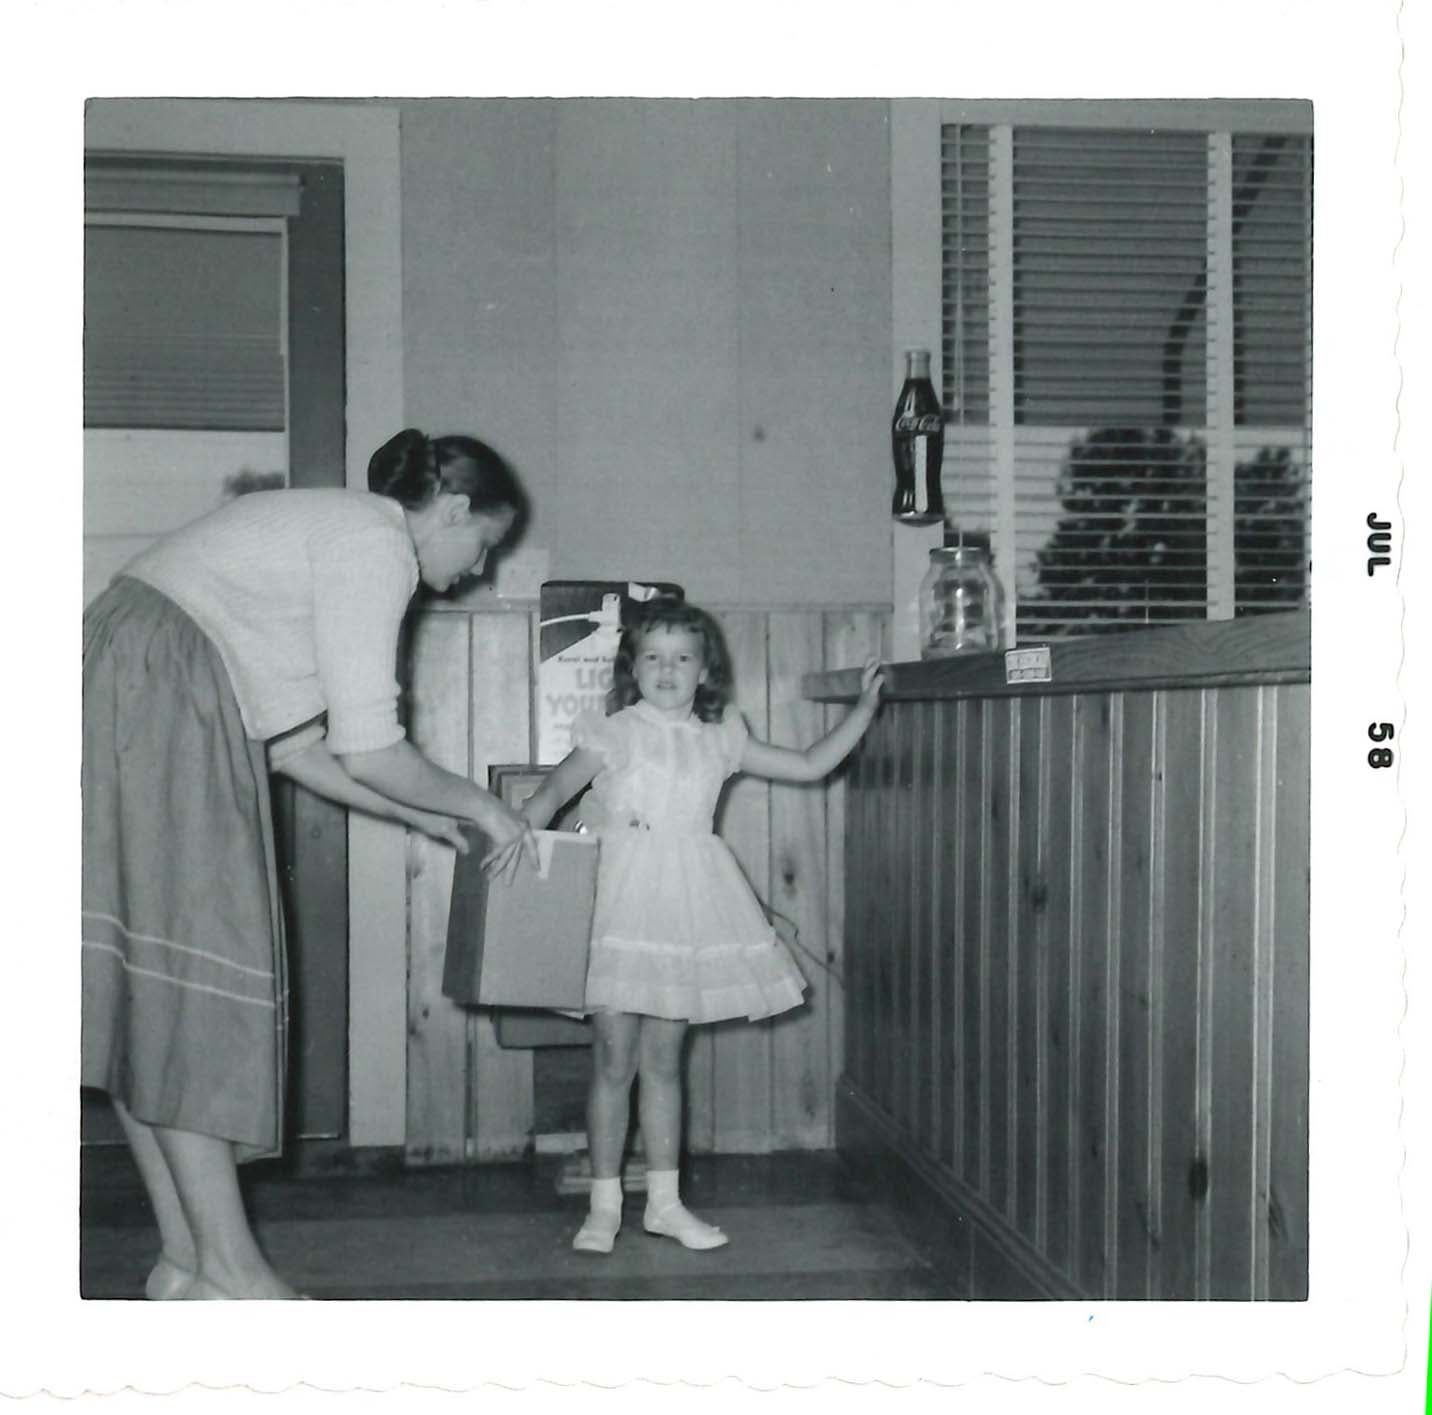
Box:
(402, 100, 887, 604)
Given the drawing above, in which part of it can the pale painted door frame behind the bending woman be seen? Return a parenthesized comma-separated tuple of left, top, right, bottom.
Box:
(84, 99, 407, 1147)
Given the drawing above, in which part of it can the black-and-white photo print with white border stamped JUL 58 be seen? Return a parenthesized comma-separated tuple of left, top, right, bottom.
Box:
(6, 3, 1429, 1409)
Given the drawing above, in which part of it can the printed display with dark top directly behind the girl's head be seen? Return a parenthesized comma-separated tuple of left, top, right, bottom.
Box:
(537, 580, 683, 765)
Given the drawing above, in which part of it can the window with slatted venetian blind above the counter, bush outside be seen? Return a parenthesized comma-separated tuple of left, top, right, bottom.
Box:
(941, 108, 1312, 640)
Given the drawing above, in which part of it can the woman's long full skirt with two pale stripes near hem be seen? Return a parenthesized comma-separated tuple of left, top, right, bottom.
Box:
(80, 577, 288, 1159)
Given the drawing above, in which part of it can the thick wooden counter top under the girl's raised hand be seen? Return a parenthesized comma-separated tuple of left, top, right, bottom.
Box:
(800, 610, 1312, 702)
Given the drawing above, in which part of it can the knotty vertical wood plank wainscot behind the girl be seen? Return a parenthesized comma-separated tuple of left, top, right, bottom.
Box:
(404, 607, 889, 1164)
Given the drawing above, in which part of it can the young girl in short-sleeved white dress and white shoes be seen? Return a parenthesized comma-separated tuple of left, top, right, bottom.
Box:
(523, 599, 882, 1253)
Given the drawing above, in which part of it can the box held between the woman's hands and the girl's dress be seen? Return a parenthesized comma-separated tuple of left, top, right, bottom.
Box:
(442, 831, 600, 1010)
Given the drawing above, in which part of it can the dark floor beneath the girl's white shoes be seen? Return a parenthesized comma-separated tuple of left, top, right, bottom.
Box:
(80, 1147, 964, 1300)
